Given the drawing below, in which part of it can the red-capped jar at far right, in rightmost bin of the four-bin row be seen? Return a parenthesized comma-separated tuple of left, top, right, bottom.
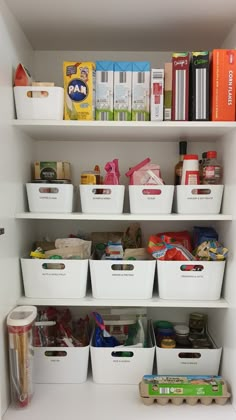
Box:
(202, 150, 223, 185)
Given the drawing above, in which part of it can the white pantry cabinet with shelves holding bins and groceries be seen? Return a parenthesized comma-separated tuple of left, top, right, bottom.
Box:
(0, 0, 236, 420)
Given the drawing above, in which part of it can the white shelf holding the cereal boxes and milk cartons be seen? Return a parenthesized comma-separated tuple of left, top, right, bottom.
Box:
(12, 120, 236, 142)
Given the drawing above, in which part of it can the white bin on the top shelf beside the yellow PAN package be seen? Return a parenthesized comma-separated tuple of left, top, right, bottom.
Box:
(14, 86, 64, 120)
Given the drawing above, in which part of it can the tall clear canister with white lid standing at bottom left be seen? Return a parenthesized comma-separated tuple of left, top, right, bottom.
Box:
(7, 306, 37, 408)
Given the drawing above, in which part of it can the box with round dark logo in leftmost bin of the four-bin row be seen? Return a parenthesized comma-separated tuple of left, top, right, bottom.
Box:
(32, 161, 71, 182)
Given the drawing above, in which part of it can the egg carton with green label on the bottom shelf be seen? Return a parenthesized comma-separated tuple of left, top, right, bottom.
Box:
(139, 375, 230, 405)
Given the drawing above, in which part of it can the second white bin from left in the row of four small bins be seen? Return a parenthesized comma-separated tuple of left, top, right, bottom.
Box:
(80, 185, 125, 214)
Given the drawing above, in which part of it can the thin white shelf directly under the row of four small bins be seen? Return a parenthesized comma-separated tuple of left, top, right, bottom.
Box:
(16, 212, 233, 222)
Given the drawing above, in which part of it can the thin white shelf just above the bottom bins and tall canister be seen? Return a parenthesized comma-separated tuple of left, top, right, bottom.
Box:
(17, 294, 229, 309)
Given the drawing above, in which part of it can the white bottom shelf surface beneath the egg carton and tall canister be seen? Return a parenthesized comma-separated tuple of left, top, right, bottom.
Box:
(3, 378, 236, 420)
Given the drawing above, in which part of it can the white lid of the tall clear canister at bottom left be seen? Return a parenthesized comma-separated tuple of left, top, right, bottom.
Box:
(7, 306, 37, 327)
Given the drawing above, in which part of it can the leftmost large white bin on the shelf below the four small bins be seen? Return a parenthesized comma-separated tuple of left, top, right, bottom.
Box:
(21, 258, 88, 298)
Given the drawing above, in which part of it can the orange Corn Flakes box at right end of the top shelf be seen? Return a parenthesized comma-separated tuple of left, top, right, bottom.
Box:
(211, 49, 236, 121)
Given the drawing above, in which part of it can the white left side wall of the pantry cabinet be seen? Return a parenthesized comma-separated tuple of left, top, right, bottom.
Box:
(0, 0, 32, 413)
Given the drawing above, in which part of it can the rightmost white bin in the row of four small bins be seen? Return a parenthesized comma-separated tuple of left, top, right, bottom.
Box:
(176, 185, 224, 214)
